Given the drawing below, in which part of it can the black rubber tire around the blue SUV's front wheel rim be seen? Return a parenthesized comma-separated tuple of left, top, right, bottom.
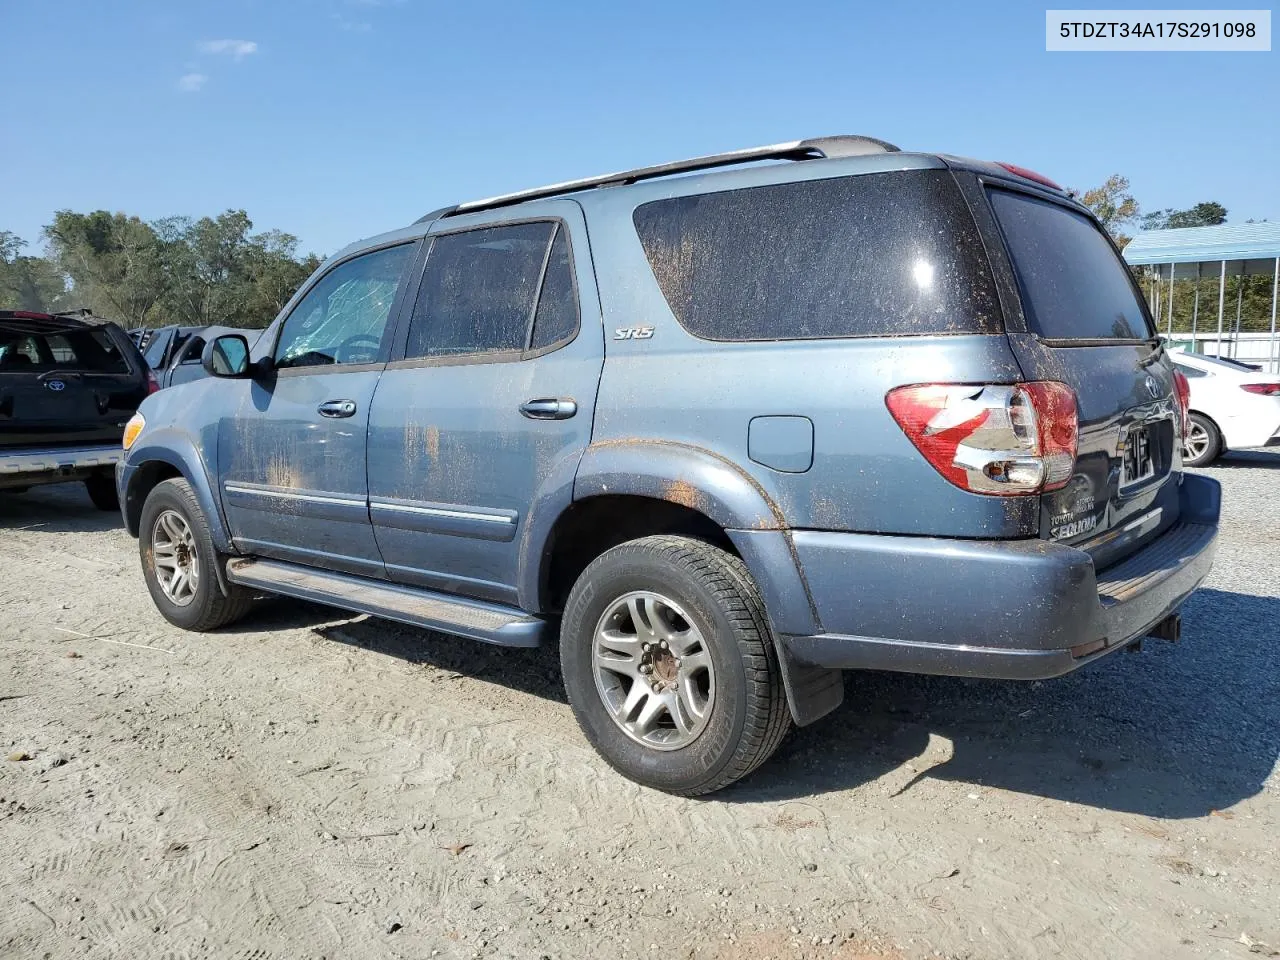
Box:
(138, 477, 252, 632)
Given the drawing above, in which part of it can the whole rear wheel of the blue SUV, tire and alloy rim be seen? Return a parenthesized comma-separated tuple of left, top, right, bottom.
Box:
(561, 536, 791, 796)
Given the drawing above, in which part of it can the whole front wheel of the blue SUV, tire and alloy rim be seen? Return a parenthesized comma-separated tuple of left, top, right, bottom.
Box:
(138, 477, 251, 631)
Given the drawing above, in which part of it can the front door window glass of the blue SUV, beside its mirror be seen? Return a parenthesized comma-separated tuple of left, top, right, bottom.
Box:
(275, 243, 413, 367)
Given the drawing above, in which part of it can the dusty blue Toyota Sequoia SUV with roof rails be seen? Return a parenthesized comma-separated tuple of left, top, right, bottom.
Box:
(118, 137, 1219, 795)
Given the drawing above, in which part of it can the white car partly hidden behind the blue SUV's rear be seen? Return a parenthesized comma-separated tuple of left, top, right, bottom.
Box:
(1170, 351, 1280, 467)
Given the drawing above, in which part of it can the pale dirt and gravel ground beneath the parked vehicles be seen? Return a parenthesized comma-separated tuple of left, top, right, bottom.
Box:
(0, 453, 1280, 960)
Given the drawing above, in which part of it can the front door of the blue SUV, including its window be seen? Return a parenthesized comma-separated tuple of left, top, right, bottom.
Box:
(218, 243, 416, 576)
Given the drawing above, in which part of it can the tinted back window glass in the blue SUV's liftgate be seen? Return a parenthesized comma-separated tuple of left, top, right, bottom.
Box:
(988, 189, 1153, 340)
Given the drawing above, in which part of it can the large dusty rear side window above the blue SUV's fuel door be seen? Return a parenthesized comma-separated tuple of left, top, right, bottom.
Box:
(634, 170, 1000, 340)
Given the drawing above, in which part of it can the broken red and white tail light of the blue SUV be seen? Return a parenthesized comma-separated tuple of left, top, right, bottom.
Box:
(884, 380, 1080, 497)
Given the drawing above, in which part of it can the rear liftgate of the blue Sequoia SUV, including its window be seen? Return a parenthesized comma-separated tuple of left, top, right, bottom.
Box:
(983, 183, 1181, 568)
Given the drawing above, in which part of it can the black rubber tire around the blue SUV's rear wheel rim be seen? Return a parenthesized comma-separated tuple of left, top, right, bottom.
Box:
(561, 536, 791, 796)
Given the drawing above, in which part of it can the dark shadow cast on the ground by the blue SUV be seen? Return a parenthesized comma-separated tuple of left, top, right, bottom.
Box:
(304, 590, 1280, 818)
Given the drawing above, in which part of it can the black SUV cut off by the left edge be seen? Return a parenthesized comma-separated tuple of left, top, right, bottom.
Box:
(0, 310, 156, 509)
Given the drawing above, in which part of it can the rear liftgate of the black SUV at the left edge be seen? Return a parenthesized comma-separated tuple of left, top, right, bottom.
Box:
(0, 319, 147, 447)
